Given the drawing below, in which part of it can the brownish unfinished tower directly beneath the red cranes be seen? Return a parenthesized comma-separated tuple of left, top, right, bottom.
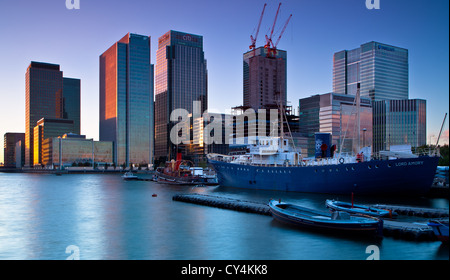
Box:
(243, 47, 287, 110)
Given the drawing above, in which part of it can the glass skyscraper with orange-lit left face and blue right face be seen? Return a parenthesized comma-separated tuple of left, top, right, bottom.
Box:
(100, 33, 154, 165)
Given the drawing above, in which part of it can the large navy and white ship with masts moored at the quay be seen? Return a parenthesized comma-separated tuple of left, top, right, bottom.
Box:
(207, 84, 445, 196)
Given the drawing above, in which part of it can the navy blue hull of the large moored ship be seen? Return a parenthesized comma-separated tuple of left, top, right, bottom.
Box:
(209, 156, 439, 196)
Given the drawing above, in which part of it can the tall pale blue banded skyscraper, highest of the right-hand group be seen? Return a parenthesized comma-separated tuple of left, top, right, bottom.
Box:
(333, 42, 409, 101)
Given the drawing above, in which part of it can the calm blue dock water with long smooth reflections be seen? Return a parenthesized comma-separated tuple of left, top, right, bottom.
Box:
(0, 173, 449, 260)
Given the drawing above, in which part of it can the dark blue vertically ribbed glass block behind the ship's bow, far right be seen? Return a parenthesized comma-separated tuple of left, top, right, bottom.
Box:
(373, 99, 427, 152)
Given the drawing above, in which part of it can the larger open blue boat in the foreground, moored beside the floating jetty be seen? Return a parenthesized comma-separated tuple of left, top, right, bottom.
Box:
(269, 200, 383, 236)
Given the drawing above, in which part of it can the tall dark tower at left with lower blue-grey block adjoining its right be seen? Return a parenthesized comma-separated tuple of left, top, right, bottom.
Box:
(25, 61, 80, 166)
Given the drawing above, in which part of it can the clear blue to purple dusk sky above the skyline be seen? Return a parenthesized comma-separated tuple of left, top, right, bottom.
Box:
(0, 0, 449, 162)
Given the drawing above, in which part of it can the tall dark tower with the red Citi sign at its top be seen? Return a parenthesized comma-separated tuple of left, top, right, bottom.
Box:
(155, 30, 208, 161)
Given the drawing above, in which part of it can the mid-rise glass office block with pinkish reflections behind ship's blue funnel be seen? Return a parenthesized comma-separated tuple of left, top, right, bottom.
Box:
(299, 93, 372, 156)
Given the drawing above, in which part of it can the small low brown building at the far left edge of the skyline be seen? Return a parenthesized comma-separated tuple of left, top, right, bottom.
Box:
(3, 132, 25, 167)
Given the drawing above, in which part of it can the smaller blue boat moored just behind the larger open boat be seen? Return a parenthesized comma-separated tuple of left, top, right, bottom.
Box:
(325, 199, 397, 218)
